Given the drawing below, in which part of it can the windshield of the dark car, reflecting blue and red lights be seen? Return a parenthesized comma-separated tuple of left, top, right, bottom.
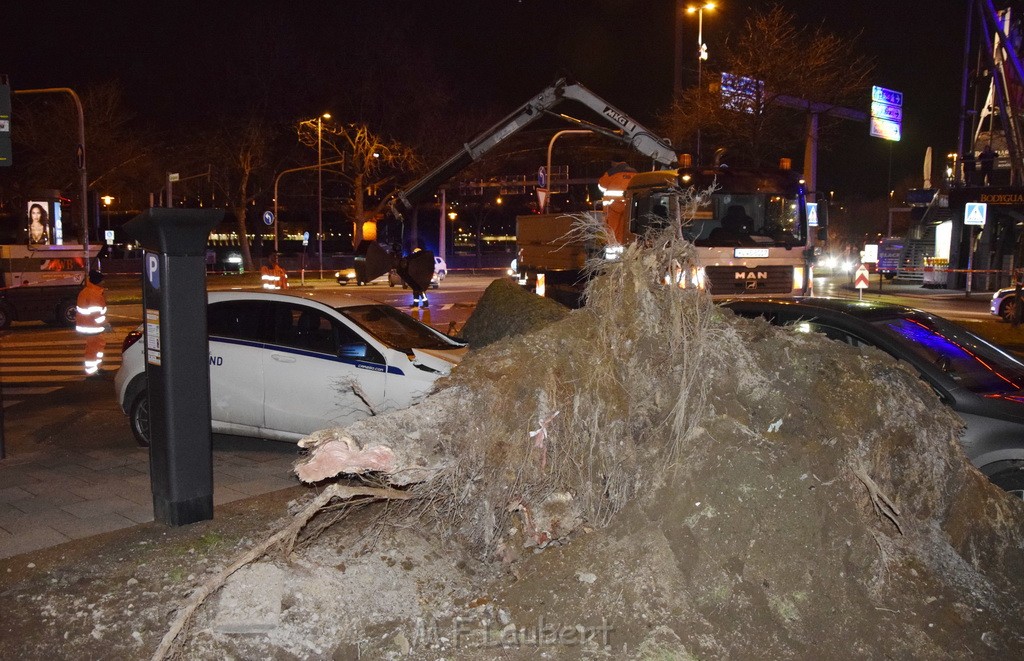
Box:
(873, 315, 1024, 396)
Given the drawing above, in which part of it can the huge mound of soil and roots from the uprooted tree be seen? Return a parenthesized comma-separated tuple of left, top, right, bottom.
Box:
(2, 204, 1024, 659)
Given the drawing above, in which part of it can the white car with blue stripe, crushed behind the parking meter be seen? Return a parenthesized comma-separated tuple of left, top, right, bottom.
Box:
(115, 291, 466, 445)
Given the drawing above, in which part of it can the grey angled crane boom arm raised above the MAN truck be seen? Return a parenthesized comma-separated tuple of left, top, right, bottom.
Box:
(391, 79, 676, 218)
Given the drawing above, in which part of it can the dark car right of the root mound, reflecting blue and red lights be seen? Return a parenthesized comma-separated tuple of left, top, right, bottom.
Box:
(722, 298, 1024, 497)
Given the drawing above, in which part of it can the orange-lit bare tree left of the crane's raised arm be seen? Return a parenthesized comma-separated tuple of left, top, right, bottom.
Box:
(297, 120, 422, 246)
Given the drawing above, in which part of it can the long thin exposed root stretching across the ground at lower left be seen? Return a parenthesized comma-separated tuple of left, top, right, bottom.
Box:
(153, 484, 416, 661)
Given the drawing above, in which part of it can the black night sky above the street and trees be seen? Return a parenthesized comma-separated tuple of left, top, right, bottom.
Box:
(0, 0, 968, 196)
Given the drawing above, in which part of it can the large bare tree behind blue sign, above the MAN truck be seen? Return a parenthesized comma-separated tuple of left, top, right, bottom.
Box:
(662, 5, 872, 166)
